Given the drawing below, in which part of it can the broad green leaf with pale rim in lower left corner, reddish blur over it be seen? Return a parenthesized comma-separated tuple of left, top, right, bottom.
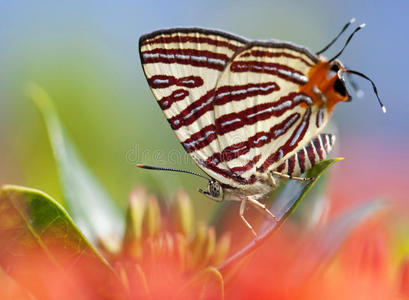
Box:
(0, 185, 123, 299)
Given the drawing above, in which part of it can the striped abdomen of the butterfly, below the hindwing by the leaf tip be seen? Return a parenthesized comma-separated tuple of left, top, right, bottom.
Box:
(276, 133, 335, 176)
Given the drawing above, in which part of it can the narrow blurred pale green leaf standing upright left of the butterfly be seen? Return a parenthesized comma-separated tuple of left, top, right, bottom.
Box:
(27, 84, 124, 245)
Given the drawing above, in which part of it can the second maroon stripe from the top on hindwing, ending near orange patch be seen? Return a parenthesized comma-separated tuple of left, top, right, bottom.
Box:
(230, 60, 308, 85)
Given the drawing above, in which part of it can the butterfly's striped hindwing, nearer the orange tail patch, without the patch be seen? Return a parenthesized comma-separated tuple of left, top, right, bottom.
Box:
(206, 42, 328, 183)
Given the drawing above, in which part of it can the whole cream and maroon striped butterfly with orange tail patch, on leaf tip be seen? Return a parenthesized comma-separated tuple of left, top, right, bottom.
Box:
(138, 20, 384, 235)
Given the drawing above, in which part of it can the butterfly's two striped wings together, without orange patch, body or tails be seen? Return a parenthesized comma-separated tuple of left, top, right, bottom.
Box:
(140, 29, 327, 187)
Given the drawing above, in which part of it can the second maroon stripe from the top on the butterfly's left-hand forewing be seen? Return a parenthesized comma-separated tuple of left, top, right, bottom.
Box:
(141, 48, 229, 71)
